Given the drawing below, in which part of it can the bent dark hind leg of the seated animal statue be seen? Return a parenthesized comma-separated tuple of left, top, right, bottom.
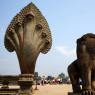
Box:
(68, 62, 81, 93)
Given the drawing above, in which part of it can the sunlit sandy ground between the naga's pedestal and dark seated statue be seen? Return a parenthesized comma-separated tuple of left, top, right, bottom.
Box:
(33, 84, 72, 95)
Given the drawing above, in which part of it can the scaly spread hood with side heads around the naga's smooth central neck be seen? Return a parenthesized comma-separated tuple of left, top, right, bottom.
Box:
(4, 3, 52, 54)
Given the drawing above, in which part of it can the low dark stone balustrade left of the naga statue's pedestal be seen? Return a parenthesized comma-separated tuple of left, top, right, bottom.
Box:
(0, 75, 19, 95)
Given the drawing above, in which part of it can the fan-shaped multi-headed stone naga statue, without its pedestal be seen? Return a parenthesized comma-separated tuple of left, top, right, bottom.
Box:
(4, 3, 52, 74)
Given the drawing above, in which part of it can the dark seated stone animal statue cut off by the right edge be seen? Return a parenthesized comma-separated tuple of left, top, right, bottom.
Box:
(68, 33, 95, 95)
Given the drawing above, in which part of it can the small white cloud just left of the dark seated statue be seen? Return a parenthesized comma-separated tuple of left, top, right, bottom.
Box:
(56, 46, 76, 57)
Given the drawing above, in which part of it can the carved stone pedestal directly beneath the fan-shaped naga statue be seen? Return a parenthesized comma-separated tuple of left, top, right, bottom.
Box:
(18, 74, 33, 95)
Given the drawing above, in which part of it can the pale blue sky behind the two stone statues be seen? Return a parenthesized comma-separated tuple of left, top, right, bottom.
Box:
(0, 0, 95, 76)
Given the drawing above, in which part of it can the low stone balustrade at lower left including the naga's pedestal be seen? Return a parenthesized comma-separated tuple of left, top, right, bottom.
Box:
(0, 74, 33, 95)
